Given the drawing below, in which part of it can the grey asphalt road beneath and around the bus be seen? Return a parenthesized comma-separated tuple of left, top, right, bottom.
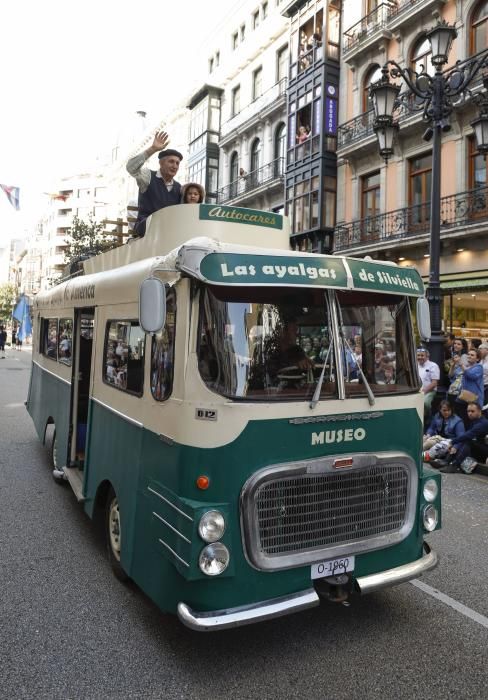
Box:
(0, 350, 488, 700)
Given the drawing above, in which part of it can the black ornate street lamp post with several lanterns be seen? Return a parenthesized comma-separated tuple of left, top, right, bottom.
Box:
(370, 21, 488, 367)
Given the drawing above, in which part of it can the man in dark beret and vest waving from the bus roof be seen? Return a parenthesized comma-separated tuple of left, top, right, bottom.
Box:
(126, 131, 183, 237)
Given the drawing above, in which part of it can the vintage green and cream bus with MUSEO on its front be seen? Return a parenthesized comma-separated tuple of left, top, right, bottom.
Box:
(27, 204, 441, 630)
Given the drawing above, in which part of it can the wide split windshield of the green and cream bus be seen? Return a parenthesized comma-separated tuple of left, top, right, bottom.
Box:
(198, 286, 418, 401)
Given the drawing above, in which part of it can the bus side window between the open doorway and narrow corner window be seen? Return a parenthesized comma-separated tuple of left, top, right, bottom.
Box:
(103, 321, 145, 396)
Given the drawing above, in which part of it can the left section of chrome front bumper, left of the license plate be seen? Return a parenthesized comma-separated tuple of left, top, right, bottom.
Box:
(178, 588, 320, 632)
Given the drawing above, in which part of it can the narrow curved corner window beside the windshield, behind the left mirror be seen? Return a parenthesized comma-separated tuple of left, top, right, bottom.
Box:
(151, 289, 176, 401)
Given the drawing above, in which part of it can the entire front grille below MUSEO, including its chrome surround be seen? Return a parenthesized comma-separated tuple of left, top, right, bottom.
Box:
(242, 455, 417, 569)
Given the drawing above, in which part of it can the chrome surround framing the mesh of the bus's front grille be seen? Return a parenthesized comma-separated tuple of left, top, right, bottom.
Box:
(240, 451, 419, 571)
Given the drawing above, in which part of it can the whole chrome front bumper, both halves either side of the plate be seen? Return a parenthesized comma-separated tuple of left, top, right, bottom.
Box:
(178, 543, 437, 632)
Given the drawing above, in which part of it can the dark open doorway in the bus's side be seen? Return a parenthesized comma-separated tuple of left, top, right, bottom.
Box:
(70, 308, 95, 467)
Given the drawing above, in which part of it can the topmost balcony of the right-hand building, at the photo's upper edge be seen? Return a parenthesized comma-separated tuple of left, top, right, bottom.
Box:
(342, 0, 446, 63)
